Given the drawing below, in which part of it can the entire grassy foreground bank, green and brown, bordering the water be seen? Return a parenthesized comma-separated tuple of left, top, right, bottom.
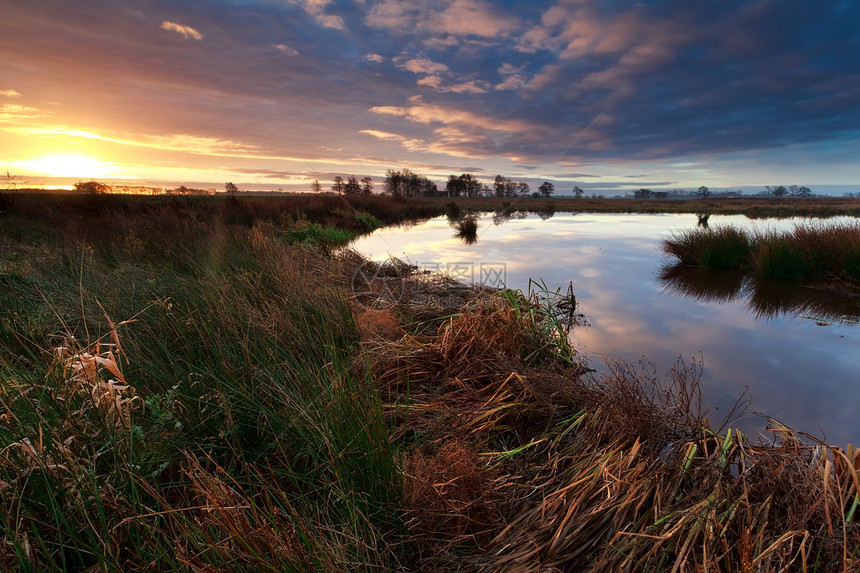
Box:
(0, 197, 860, 571)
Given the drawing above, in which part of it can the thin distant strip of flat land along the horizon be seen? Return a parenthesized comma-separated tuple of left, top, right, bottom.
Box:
(5, 191, 860, 223)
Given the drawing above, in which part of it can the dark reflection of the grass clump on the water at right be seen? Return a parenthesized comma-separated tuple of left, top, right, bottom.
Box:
(658, 263, 860, 325)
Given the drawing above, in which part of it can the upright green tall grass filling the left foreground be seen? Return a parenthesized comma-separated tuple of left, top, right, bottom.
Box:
(0, 209, 402, 571)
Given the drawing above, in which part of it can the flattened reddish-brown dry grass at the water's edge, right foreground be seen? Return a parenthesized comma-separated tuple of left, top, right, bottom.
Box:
(352, 270, 860, 572)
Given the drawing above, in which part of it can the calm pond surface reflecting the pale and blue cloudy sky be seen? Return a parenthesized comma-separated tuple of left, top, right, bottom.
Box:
(353, 212, 860, 445)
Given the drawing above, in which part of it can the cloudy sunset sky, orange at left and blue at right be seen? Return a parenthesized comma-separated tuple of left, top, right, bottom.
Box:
(0, 0, 860, 195)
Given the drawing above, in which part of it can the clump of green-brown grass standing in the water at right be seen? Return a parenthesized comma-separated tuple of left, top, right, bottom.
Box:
(663, 223, 860, 285)
